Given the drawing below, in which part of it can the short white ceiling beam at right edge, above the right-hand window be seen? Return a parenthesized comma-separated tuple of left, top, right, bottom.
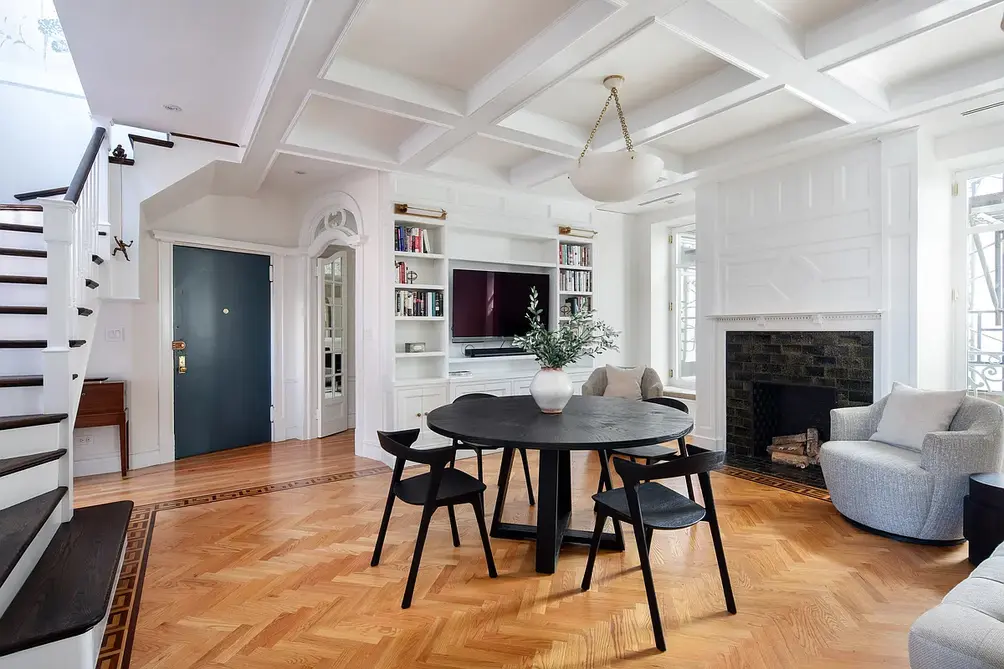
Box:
(889, 53, 1004, 110)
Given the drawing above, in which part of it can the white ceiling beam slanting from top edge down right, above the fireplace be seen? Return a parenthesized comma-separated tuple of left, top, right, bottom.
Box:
(661, 0, 888, 123)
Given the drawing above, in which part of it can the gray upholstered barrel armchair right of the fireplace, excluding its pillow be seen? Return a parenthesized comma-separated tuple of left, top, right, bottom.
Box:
(819, 397, 1004, 542)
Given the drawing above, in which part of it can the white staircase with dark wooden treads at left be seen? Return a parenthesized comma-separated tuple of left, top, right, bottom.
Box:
(0, 128, 133, 669)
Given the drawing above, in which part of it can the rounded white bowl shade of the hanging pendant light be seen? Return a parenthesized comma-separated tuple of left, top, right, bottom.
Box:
(569, 151, 663, 202)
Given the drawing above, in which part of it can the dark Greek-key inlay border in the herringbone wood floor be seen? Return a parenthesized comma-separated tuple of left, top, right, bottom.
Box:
(97, 458, 829, 669)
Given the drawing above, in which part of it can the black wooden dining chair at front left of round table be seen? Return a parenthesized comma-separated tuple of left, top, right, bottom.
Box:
(369, 430, 498, 609)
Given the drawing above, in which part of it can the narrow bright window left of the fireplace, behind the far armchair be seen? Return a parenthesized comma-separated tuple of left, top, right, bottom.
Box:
(669, 229, 697, 388)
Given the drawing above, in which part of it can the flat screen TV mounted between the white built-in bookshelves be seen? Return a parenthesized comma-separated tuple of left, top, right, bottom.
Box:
(452, 269, 550, 341)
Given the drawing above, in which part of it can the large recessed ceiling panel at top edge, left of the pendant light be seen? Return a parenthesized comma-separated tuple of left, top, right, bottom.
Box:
(338, 0, 575, 90)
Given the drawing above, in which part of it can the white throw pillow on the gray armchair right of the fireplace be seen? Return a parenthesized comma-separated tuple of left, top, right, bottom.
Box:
(871, 384, 966, 452)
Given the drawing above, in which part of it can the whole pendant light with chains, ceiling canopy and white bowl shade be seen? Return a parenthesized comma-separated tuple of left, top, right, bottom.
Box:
(568, 74, 663, 202)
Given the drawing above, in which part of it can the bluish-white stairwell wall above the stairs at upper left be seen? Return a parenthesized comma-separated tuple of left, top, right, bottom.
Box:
(0, 82, 92, 203)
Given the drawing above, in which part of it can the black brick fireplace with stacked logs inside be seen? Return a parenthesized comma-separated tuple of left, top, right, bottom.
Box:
(725, 330, 874, 485)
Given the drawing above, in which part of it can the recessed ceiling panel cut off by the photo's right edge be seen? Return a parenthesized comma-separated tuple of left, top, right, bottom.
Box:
(831, 7, 1004, 85)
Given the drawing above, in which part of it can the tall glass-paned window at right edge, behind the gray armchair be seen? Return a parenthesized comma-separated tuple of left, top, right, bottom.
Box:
(966, 174, 1004, 394)
